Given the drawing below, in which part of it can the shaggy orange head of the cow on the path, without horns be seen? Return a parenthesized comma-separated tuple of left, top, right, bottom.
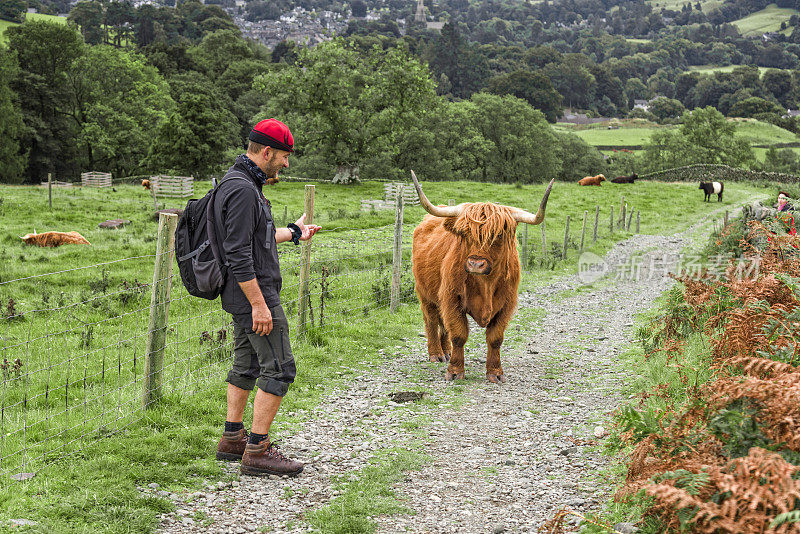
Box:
(444, 202, 517, 275)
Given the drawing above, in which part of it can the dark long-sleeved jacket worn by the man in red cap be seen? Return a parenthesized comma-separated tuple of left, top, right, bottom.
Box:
(214, 159, 282, 314)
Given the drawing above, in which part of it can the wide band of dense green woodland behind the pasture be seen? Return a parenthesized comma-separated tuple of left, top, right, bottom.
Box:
(0, 0, 800, 183)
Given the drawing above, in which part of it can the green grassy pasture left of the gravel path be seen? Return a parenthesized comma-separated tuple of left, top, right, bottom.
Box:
(0, 177, 764, 532)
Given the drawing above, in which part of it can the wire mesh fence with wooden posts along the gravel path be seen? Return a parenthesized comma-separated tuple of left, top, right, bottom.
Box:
(0, 191, 652, 482)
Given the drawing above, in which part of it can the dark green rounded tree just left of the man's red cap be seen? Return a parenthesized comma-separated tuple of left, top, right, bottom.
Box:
(148, 73, 239, 177)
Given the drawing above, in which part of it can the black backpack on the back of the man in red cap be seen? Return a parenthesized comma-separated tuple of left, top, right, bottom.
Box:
(175, 171, 256, 300)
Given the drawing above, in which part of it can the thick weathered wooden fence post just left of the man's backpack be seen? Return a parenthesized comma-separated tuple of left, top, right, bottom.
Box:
(142, 213, 178, 408)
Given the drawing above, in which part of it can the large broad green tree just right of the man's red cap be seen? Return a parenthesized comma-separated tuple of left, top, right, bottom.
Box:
(254, 39, 435, 182)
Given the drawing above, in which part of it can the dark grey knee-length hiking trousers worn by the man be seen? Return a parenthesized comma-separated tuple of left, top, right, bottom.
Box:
(226, 304, 297, 397)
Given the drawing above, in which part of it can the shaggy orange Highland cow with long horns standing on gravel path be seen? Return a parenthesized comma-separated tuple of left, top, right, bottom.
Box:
(411, 172, 553, 383)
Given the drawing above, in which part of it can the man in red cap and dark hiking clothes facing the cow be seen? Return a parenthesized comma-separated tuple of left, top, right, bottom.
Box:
(214, 119, 320, 476)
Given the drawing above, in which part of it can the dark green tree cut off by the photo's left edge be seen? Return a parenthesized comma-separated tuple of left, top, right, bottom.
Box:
(0, 46, 28, 183)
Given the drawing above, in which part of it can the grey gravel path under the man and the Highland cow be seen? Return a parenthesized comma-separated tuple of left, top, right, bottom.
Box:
(148, 210, 732, 533)
